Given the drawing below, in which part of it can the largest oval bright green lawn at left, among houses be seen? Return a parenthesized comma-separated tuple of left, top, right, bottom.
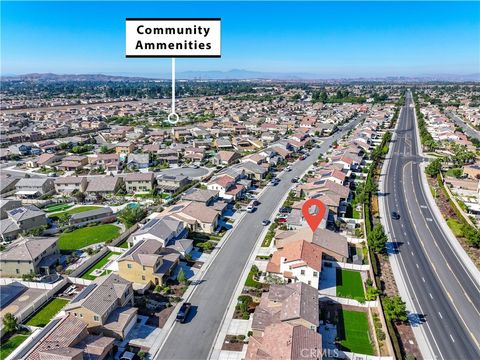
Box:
(58, 224, 120, 250)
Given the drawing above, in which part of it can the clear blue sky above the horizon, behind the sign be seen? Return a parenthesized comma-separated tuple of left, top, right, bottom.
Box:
(1, 1, 480, 77)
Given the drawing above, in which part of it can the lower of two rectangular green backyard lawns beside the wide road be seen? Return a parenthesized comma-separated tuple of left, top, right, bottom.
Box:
(337, 310, 374, 355)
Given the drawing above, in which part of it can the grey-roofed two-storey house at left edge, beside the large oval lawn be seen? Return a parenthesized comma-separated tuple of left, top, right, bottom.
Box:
(0, 237, 62, 278)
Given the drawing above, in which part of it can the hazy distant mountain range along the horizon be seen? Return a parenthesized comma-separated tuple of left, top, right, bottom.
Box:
(1, 69, 480, 83)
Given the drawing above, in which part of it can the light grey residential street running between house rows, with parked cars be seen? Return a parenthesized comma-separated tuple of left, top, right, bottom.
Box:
(156, 118, 361, 360)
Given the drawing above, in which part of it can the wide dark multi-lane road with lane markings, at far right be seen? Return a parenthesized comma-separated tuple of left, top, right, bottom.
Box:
(384, 94, 480, 360)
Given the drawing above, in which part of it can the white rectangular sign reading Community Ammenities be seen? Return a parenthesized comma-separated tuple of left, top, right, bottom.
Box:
(126, 18, 221, 58)
